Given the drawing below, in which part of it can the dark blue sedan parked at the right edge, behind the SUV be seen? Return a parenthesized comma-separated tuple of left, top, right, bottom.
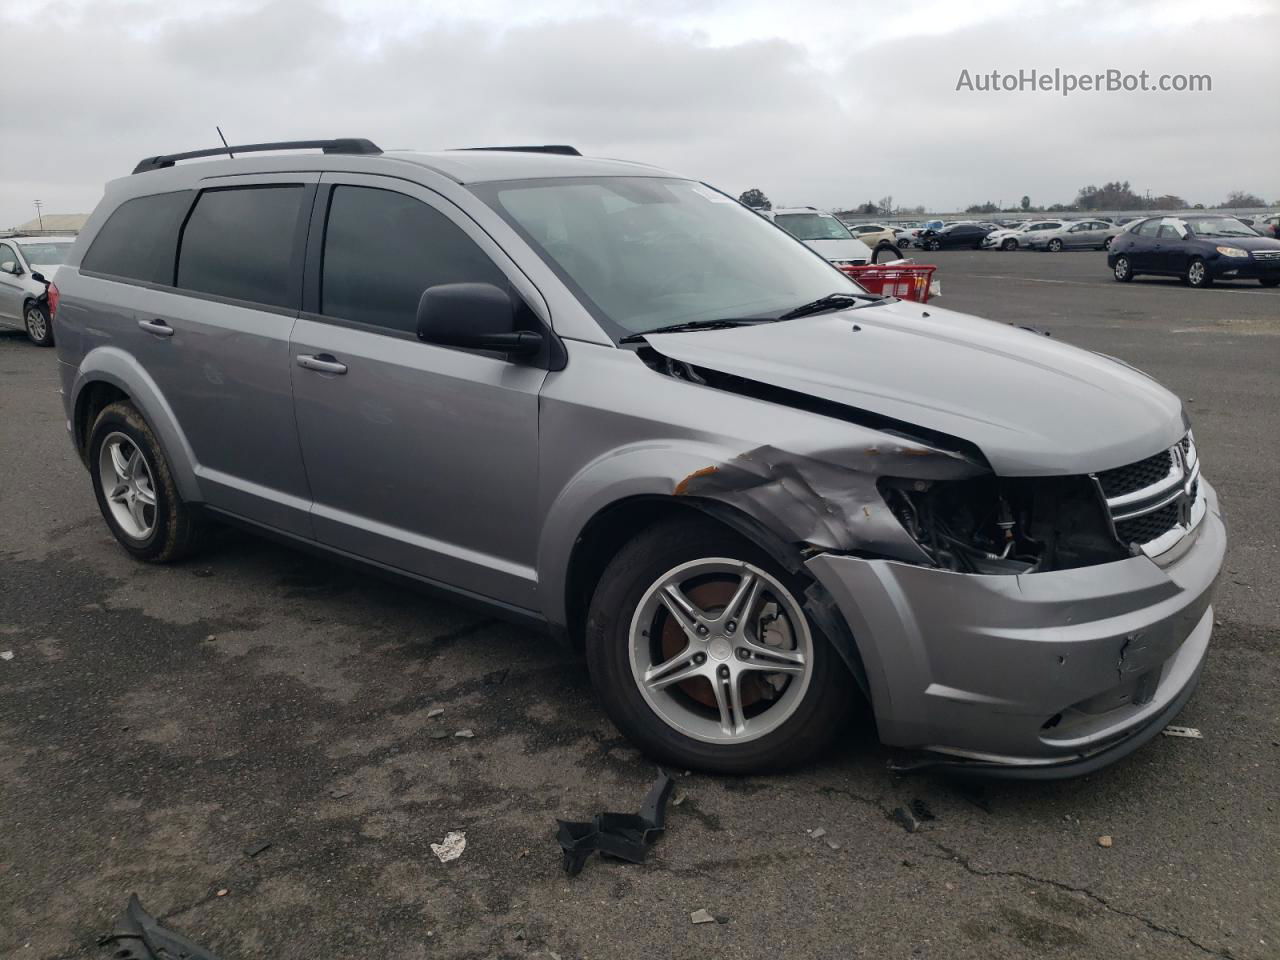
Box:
(1107, 215, 1280, 287)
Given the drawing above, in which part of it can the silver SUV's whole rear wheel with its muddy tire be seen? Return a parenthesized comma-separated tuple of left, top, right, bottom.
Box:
(88, 401, 201, 563)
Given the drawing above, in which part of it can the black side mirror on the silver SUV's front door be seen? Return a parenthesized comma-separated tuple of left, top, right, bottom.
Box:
(417, 283, 543, 356)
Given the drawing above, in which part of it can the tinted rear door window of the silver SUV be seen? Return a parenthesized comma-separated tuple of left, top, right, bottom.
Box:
(178, 183, 303, 307)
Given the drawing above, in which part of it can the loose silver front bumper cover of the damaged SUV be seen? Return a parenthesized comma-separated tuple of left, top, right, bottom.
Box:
(808, 484, 1226, 777)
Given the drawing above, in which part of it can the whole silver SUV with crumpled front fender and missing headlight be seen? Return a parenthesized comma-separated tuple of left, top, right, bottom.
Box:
(56, 140, 1225, 777)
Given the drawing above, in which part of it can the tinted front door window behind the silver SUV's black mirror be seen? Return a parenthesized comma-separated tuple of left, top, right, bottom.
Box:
(320, 187, 507, 332)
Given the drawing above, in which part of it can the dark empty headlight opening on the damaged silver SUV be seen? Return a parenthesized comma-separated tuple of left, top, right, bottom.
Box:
(879, 475, 1128, 573)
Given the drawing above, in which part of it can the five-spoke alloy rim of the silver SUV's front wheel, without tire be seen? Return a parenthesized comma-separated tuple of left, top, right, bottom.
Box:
(628, 558, 813, 744)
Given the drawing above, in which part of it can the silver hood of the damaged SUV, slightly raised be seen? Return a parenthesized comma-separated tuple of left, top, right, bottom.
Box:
(646, 301, 1187, 476)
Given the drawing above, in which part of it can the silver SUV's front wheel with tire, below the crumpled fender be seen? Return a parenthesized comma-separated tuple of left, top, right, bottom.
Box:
(586, 518, 854, 773)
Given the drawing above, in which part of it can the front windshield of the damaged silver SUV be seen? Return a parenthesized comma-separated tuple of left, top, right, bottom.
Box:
(474, 177, 864, 339)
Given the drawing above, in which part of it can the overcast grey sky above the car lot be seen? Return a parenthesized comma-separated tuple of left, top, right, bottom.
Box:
(0, 0, 1280, 225)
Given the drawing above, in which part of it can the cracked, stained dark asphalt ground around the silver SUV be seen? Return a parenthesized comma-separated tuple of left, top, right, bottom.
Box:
(0, 251, 1280, 960)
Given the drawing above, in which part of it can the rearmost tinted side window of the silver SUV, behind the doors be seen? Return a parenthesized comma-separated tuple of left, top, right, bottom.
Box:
(81, 191, 191, 284)
